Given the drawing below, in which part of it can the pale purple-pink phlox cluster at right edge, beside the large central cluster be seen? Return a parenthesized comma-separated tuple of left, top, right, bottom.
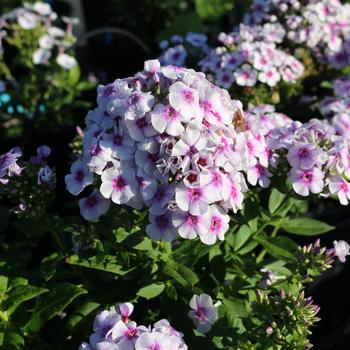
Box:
(248, 102, 350, 205)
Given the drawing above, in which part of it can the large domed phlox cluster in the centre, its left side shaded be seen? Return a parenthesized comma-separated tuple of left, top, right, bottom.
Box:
(66, 60, 268, 244)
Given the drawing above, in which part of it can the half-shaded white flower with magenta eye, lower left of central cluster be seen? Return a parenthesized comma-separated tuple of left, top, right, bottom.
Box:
(100, 167, 138, 204)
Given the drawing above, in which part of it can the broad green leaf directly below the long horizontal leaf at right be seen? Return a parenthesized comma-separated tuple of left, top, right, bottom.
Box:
(254, 235, 297, 260)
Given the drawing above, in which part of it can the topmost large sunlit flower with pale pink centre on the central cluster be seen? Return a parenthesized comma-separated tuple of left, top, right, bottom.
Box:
(169, 81, 202, 121)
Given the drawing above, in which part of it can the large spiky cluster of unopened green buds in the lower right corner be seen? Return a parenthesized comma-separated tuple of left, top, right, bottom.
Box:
(252, 290, 320, 349)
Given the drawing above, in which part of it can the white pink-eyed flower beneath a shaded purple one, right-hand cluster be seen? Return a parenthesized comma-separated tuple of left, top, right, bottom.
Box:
(289, 168, 324, 197)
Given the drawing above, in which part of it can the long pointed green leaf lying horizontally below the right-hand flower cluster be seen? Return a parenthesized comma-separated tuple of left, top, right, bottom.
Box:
(282, 218, 334, 236)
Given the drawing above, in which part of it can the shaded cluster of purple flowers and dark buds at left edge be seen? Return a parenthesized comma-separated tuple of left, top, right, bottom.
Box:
(0, 146, 56, 217)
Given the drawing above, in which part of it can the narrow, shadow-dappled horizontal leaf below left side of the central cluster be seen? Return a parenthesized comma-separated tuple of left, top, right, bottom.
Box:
(66, 255, 136, 276)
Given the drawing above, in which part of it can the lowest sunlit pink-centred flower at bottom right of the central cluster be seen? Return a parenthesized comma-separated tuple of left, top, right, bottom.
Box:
(199, 205, 230, 245)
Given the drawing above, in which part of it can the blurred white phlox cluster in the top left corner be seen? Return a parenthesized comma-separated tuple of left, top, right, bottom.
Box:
(0, 1, 78, 70)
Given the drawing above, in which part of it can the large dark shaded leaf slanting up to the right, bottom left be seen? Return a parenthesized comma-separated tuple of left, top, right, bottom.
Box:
(24, 283, 87, 333)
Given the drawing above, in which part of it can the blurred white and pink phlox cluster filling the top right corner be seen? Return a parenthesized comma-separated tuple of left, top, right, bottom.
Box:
(245, 0, 350, 68)
